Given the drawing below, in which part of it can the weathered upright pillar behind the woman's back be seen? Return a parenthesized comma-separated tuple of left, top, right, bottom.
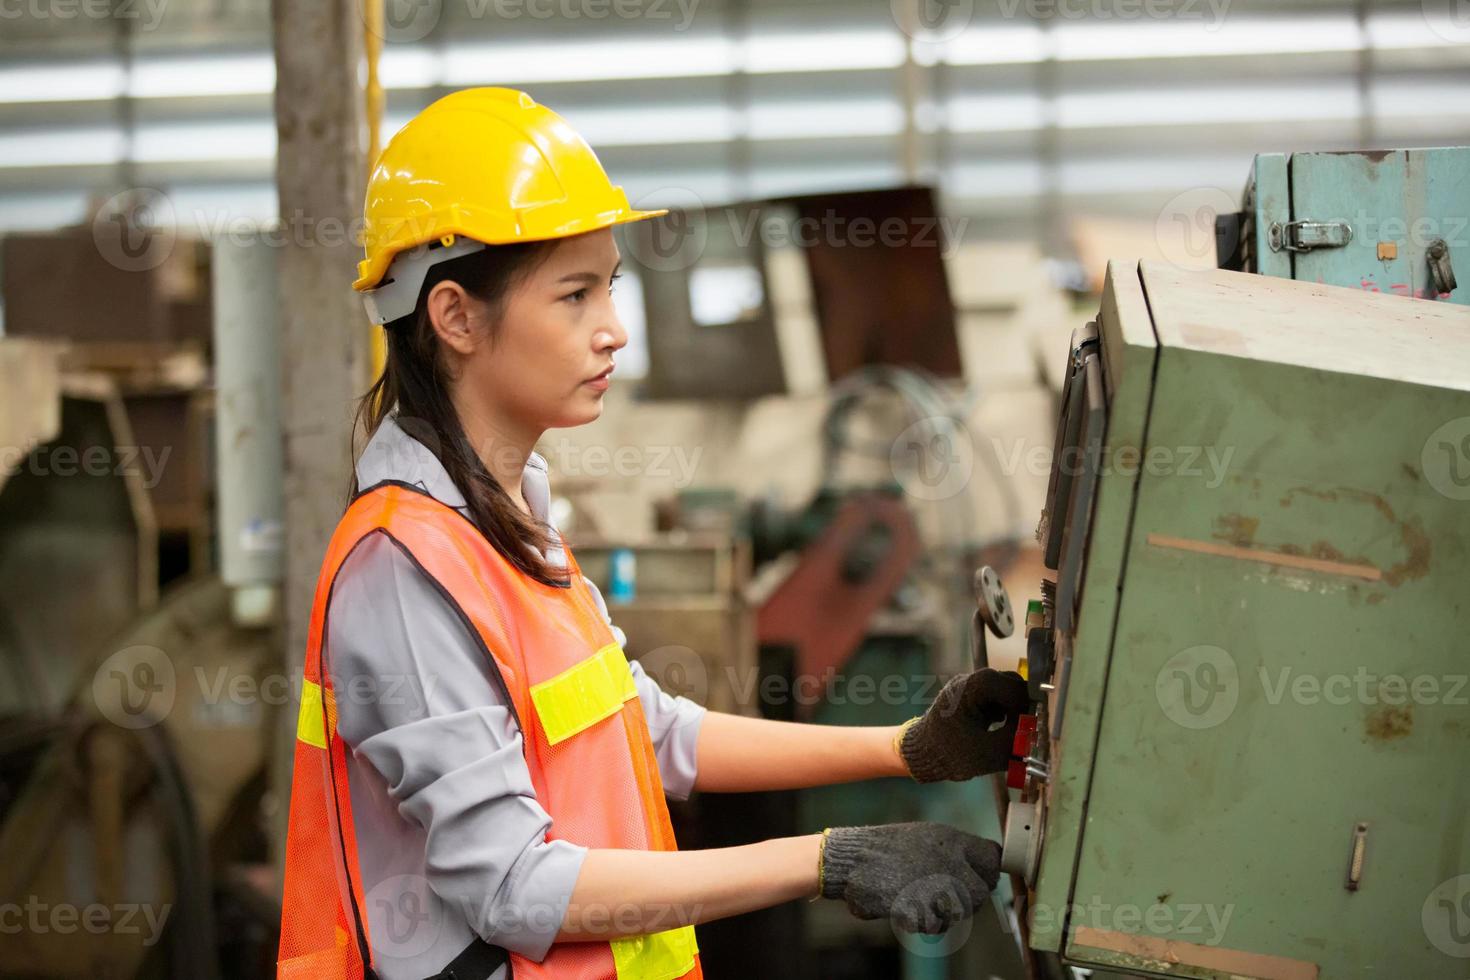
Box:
(270, 0, 370, 868)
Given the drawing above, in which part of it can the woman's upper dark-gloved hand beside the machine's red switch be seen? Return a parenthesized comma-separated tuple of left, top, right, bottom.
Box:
(895, 667, 1030, 783)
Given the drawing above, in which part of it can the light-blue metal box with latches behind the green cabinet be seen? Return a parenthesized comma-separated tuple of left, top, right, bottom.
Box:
(1216, 147, 1470, 306)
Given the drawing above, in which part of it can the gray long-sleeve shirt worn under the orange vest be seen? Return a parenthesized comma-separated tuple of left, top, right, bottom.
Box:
(323, 417, 704, 980)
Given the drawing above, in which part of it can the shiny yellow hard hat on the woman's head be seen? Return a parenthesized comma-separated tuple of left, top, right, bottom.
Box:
(353, 88, 667, 322)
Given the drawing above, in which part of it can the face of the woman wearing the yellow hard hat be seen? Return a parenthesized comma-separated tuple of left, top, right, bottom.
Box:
(441, 228, 628, 436)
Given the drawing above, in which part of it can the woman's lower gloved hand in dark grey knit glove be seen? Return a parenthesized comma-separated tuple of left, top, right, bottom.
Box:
(820, 823, 1001, 934)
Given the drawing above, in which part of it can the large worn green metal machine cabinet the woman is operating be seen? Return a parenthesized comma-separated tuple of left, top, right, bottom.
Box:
(1005, 262, 1470, 980)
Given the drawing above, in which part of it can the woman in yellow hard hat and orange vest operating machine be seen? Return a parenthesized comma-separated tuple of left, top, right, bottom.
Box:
(279, 88, 1026, 980)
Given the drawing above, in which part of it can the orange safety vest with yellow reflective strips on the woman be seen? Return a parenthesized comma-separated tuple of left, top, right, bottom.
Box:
(276, 483, 704, 980)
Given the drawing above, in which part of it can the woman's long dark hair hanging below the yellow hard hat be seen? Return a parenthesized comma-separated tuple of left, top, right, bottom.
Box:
(353, 239, 566, 585)
